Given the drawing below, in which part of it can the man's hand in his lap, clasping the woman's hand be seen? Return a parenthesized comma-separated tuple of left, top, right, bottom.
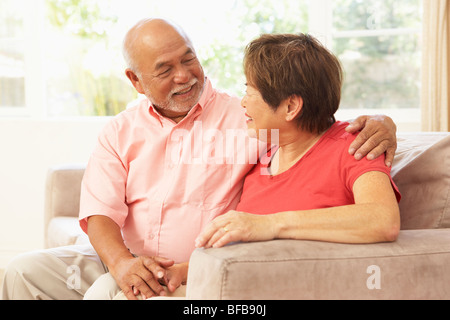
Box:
(110, 257, 174, 300)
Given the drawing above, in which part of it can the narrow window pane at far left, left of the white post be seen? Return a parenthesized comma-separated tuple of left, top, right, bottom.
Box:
(0, 0, 44, 116)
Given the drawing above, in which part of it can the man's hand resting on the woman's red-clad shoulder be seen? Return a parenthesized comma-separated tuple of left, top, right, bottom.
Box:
(346, 115, 397, 167)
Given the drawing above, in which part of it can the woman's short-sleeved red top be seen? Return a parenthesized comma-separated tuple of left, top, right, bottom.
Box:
(236, 122, 401, 214)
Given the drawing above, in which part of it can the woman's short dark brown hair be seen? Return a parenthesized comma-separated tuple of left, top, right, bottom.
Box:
(244, 34, 343, 133)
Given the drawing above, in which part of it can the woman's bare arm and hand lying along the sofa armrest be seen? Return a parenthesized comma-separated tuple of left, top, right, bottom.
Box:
(196, 171, 400, 248)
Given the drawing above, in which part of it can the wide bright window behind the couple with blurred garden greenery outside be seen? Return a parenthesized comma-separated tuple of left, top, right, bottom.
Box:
(0, 0, 422, 130)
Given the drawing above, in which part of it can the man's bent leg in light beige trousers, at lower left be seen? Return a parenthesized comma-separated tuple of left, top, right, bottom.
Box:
(2, 245, 107, 300)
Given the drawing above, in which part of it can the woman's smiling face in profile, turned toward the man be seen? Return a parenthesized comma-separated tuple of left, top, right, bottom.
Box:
(241, 84, 285, 142)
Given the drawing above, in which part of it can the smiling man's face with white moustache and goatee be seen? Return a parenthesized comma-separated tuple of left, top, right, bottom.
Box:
(134, 37, 205, 118)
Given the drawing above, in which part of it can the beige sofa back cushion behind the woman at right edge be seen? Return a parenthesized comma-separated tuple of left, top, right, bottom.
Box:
(392, 133, 450, 230)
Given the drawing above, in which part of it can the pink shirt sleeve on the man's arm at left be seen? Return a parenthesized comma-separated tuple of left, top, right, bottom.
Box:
(79, 122, 128, 233)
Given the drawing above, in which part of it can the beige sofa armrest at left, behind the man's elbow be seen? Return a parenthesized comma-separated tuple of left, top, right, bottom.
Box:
(45, 164, 85, 238)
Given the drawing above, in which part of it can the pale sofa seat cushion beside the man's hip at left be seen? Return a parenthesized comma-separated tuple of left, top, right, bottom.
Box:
(47, 217, 89, 248)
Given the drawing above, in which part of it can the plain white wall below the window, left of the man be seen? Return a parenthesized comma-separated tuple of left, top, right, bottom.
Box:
(0, 118, 109, 268)
